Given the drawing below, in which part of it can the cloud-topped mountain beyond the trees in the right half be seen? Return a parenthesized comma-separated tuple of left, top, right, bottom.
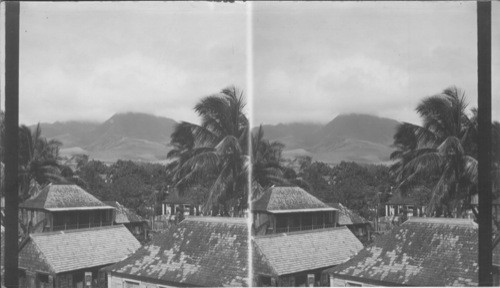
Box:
(256, 114, 399, 164)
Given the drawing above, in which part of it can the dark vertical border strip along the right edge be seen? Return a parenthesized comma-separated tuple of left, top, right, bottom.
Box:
(477, 1, 493, 286)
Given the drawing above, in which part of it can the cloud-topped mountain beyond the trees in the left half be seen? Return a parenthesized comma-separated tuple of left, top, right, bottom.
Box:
(35, 113, 176, 162)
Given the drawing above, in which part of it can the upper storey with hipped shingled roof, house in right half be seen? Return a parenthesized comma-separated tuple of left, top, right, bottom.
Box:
(251, 187, 337, 235)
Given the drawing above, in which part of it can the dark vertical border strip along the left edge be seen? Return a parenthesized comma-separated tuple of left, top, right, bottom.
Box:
(5, 1, 20, 287)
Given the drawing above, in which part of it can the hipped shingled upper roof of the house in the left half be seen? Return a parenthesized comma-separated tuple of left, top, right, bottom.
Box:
(19, 184, 113, 211)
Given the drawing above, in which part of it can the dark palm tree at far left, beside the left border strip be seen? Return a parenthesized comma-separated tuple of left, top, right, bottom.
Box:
(19, 124, 64, 201)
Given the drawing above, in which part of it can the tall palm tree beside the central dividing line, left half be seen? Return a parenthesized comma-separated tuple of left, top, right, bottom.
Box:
(169, 87, 249, 211)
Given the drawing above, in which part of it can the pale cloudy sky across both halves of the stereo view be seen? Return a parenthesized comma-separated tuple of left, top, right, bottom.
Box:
(0, 1, 500, 125)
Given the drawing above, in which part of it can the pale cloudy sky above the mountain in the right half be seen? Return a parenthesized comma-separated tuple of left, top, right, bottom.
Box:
(253, 2, 500, 124)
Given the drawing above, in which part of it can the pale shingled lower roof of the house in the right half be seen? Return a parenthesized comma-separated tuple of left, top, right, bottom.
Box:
(254, 227, 363, 275)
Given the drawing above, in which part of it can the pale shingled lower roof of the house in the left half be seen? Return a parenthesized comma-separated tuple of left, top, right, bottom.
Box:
(19, 225, 141, 273)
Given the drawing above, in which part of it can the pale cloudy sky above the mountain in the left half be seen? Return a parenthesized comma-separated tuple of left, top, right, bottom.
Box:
(1, 2, 247, 124)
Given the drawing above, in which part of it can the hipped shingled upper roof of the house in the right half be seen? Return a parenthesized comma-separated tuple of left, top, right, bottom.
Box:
(252, 187, 336, 213)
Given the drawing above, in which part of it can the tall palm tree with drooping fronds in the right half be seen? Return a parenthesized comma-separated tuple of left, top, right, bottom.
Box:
(391, 87, 477, 216)
